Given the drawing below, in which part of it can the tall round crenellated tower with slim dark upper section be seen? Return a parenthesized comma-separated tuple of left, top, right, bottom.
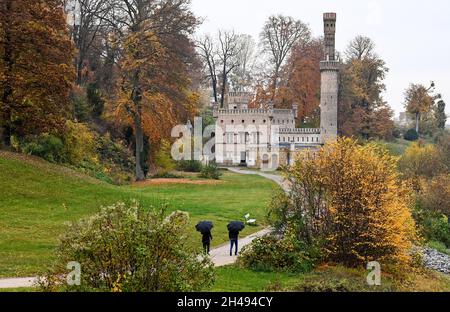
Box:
(320, 13, 339, 143)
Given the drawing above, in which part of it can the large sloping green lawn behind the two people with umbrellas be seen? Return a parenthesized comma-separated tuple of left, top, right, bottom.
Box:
(0, 151, 277, 277)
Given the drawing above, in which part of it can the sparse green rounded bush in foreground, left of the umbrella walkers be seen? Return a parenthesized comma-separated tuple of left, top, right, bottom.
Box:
(40, 202, 214, 292)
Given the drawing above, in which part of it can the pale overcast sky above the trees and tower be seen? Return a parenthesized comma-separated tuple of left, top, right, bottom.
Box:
(192, 0, 450, 114)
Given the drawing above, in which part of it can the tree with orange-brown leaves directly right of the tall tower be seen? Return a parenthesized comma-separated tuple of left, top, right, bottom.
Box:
(339, 36, 394, 139)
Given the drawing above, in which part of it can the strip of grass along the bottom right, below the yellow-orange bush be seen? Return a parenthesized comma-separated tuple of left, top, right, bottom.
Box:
(212, 266, 450, 292)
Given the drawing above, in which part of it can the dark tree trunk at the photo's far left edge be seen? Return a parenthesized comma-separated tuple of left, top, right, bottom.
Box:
(0, 0, 13, 146)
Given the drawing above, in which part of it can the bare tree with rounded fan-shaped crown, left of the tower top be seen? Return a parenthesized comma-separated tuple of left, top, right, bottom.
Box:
(260, 15, 311, 100)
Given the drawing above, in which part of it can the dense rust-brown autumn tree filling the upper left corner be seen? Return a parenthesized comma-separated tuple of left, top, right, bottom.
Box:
(0, 0, 74, 145)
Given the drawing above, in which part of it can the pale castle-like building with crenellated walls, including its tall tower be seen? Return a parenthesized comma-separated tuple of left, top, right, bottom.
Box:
(214, 13, 339, 168)
